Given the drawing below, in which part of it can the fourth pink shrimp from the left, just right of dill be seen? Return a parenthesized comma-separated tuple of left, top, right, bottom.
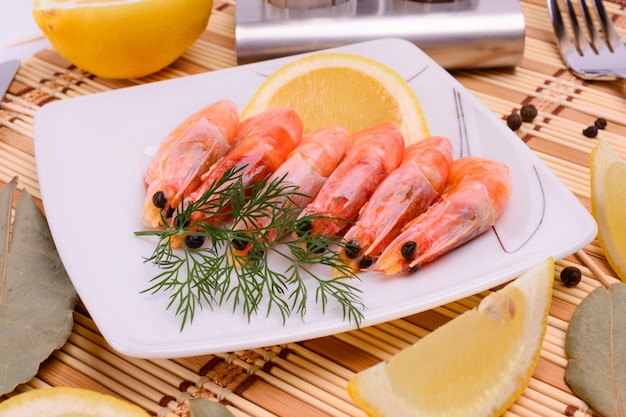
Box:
(299, 122, 404, 236)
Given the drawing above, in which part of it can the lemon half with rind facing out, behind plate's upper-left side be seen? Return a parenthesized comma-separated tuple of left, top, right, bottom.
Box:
(33, 0, 213, 78)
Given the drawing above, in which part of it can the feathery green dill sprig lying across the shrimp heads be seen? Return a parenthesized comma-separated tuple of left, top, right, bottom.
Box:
(135, 168, 365, 330)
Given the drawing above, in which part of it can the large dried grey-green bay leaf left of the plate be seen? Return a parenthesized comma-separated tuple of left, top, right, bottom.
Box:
(0, 178, 77, 394)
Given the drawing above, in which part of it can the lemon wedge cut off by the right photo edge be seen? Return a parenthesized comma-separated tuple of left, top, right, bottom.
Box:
(591, 138, 626, 281)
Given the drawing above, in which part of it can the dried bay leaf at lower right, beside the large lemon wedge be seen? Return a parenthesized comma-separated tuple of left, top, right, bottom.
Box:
(565, 282, 626, 417)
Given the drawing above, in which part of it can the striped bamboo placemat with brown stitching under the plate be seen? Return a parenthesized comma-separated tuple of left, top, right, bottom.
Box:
(0, 0, 626, 417)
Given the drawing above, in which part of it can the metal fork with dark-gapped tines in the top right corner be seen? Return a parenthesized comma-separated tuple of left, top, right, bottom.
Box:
(546, 0, 626, 80)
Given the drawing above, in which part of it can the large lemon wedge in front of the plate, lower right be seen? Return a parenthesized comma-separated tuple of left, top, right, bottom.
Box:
(348, 258, 554, 417)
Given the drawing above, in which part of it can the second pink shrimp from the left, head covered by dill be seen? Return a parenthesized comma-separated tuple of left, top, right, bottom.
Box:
(186, 107, 303, 226)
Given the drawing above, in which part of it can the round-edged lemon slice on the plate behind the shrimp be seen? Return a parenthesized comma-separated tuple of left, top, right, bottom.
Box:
(242, 52, 430, 144)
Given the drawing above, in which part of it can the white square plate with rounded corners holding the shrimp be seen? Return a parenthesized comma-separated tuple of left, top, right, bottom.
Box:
(34, 39, 596, 357)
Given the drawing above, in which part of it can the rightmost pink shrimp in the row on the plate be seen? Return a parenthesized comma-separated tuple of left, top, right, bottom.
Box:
(374, 157, 511, 275)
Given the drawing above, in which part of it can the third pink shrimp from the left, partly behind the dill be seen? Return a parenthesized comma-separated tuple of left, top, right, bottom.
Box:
(232, 126, 348, 255)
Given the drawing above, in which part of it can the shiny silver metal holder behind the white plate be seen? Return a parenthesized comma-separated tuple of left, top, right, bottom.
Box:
(235, 0, 525, 69)
